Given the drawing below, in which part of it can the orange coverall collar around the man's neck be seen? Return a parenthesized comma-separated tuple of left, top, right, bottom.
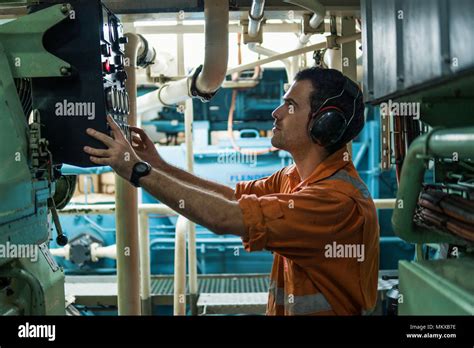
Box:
(286, 146, 350, 187)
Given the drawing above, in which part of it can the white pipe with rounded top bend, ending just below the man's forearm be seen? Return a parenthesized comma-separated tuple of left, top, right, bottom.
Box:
(173, 215, 189, 315)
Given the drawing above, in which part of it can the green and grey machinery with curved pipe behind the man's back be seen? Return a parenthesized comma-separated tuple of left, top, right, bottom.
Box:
(361, 0, 474, 315)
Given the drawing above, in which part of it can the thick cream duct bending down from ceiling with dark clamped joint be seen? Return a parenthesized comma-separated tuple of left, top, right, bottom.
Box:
(137, 0, 229, 115)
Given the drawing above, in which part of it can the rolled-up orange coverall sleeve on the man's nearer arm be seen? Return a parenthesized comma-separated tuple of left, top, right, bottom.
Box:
(239, 188, 364, 264)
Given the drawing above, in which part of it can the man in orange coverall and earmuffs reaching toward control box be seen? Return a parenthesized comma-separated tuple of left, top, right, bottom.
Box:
(84, 68, 379, 315)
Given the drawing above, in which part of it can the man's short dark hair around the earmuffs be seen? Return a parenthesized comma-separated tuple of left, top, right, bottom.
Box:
(295, 67, 365, 154)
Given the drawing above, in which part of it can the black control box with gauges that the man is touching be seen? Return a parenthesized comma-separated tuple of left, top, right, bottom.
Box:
(29, 0, 130, 167)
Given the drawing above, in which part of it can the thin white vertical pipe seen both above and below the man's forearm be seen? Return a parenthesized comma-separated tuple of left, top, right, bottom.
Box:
(182, 99, 198, 315)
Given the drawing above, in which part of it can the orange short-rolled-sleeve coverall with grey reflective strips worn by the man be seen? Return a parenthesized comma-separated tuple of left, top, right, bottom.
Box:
(235, 147, 379, 315)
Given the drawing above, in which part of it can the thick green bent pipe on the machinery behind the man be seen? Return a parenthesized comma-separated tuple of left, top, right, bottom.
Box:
(392, 127, 474, 243)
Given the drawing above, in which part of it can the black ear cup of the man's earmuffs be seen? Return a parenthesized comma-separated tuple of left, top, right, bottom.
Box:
(309, 106, 347, 147)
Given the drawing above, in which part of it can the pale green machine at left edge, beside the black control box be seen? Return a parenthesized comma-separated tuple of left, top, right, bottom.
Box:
(0, 5, 75, 315)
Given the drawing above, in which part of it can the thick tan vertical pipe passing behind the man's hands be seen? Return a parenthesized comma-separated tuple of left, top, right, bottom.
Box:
(115, 33, 140, 315)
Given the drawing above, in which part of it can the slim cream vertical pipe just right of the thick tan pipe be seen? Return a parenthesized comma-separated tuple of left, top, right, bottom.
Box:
(140, 212, 152, 315)
